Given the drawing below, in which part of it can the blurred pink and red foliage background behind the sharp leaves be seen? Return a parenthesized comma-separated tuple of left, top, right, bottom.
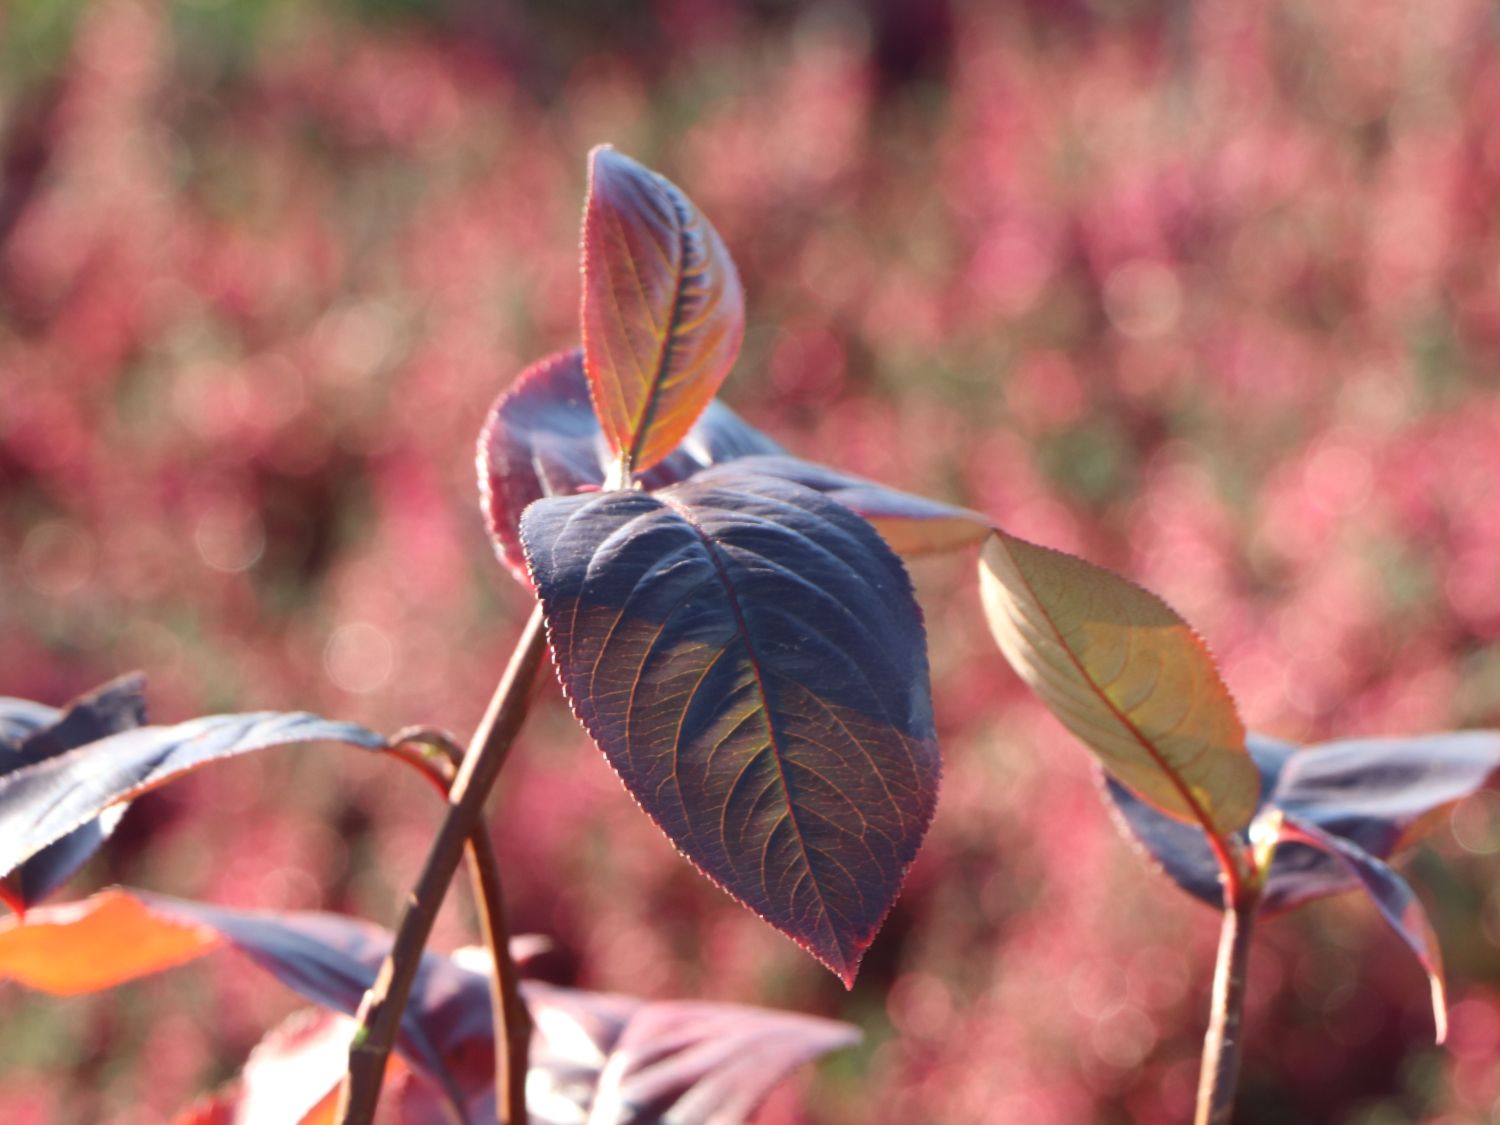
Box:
(0, 0, 1500, 1125)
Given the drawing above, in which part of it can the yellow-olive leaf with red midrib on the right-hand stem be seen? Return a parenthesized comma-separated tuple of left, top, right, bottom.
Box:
(980, 531, 1260, 840)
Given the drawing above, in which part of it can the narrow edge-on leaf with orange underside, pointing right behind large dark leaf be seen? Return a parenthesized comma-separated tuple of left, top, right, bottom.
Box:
(698, 456, 993, 555)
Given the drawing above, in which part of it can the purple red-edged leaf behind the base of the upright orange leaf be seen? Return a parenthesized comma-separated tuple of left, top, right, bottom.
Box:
(479, 348, 782, 585)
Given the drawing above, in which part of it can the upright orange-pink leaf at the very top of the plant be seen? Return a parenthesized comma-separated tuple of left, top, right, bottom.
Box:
(582, 146, 744, 473)
